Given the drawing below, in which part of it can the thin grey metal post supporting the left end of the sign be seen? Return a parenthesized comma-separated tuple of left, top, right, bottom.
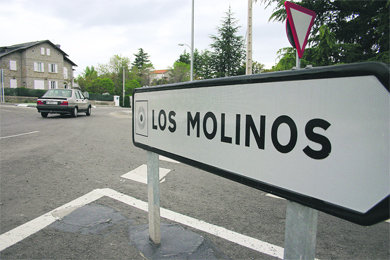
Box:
(147, 151, 161, 245)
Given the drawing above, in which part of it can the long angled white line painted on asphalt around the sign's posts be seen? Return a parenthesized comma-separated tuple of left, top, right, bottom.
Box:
(0, 188, 284, 259)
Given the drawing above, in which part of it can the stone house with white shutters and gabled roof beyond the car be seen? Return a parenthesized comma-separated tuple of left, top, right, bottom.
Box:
(0, 40, 77, 89)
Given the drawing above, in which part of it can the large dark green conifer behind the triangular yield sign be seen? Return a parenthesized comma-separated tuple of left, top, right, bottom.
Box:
(263, 0, 390, 65)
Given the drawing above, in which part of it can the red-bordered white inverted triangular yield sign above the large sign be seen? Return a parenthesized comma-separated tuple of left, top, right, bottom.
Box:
(284, 1, 316, 58)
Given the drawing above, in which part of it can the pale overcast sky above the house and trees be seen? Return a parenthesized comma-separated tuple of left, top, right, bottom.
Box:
(0, 0, 289, 75)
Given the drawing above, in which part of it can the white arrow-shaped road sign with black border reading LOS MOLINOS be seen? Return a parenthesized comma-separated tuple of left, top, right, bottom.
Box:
(133, 63, 390, 225)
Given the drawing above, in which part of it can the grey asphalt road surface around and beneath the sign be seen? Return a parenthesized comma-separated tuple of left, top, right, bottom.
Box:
(0, 105, 390, 259)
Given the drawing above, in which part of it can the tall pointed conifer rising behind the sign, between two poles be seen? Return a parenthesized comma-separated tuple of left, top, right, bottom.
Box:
(210, 7, 245, 78)
